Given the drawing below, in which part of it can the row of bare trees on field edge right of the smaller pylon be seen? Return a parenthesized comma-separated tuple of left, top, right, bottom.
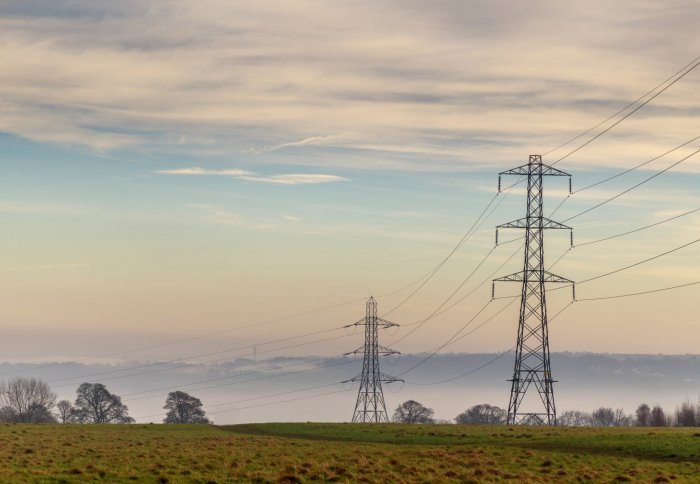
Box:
(392, 400, 700, 427)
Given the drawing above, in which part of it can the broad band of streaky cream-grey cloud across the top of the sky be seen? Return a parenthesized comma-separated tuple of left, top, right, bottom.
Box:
(0, 0, 700, 170)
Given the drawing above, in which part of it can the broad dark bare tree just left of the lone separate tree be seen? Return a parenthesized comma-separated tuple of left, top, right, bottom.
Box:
(75, 383, 134, 423)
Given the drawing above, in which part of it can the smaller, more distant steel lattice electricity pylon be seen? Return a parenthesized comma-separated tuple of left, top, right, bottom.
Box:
(343, 297, 403, 423)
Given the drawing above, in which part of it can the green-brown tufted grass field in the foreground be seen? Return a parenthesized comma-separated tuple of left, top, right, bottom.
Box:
(0, 423, 700, 483)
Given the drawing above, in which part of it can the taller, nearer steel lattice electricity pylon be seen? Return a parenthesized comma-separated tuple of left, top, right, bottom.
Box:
(494, 155, 573, 425)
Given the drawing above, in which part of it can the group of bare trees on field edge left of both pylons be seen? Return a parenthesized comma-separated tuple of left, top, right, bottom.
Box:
(0, 377, 211, 424)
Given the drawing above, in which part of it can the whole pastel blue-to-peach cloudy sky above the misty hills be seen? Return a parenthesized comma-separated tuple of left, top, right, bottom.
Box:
(0, 0, 700, 378)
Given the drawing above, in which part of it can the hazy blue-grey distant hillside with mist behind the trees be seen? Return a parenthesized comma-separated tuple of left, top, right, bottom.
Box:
(0, 353, 700, 423)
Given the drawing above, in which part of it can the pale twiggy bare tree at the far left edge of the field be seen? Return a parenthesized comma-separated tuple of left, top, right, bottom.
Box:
(0, 377, 56, 423)
